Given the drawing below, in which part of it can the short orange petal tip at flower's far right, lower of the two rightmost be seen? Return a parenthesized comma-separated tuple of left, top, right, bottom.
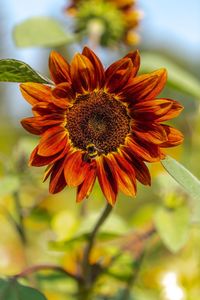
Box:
(160, 125, 184, 148)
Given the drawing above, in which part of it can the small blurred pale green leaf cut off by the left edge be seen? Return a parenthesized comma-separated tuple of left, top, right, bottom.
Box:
(0, 175, 19, 197)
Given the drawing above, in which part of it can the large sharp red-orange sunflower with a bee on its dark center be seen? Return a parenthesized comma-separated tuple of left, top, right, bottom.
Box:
(20, 47, 183, 205)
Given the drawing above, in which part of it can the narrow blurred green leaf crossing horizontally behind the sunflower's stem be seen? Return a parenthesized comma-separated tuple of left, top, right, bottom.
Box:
(49, 232, 121, 251)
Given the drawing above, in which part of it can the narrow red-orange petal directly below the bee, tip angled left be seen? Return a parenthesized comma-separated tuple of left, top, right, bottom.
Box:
(76, 164, 96, 202)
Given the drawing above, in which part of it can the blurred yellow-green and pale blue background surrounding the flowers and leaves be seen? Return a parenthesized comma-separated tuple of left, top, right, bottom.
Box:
(0, 0, 200, 300)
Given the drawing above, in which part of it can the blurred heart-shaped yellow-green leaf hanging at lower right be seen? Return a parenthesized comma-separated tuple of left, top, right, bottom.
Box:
(154, 206, 189, 252)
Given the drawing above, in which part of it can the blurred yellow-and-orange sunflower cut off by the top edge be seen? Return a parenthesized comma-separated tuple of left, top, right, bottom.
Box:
(66, 0, 142, 46)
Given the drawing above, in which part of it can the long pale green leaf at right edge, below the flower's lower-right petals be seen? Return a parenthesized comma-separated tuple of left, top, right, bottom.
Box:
(161, 156, 200, 222)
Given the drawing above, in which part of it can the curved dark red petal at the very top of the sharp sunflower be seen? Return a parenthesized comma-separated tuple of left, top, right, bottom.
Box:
(82, 47, 105, 88)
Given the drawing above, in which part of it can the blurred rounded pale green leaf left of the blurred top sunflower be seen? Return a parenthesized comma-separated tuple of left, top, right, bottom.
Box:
(13, 17, 71, 47)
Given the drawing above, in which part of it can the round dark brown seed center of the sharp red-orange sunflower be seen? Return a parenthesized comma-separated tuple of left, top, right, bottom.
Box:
(66, 91, 130, 154)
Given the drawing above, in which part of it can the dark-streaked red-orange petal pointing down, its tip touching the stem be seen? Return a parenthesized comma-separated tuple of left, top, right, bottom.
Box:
(96, 155, 118, 205)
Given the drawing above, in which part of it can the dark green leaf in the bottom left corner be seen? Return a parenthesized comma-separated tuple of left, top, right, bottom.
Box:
(0, 279, 47, 300)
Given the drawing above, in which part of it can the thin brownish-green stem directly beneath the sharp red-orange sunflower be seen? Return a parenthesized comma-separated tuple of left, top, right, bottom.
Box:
(82, 204, 113, 292)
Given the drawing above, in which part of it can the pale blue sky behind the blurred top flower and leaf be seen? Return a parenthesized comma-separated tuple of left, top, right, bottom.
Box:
(0, 0, 200, 117)
